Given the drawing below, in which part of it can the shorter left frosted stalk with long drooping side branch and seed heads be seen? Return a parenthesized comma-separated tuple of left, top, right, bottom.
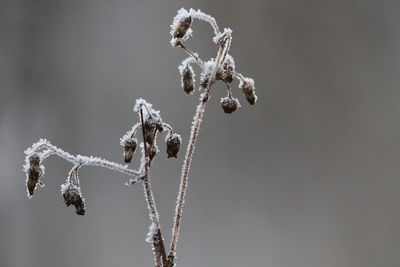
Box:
(23, 99, 181, 266)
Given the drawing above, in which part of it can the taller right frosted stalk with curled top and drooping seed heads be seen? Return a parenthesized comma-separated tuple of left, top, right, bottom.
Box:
(167, 9, 256, 266)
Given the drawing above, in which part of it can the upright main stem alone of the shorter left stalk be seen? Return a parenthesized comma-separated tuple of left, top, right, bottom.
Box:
(140, 110, 167, 267)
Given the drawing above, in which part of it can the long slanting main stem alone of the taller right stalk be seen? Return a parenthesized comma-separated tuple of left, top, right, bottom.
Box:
(170, 38, 230, 257)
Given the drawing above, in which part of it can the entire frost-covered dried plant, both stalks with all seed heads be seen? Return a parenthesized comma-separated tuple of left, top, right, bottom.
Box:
(23, 8, 257, 267)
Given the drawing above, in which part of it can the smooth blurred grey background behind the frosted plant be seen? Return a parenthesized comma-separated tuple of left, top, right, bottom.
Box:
(0, 0, 400, 267)
